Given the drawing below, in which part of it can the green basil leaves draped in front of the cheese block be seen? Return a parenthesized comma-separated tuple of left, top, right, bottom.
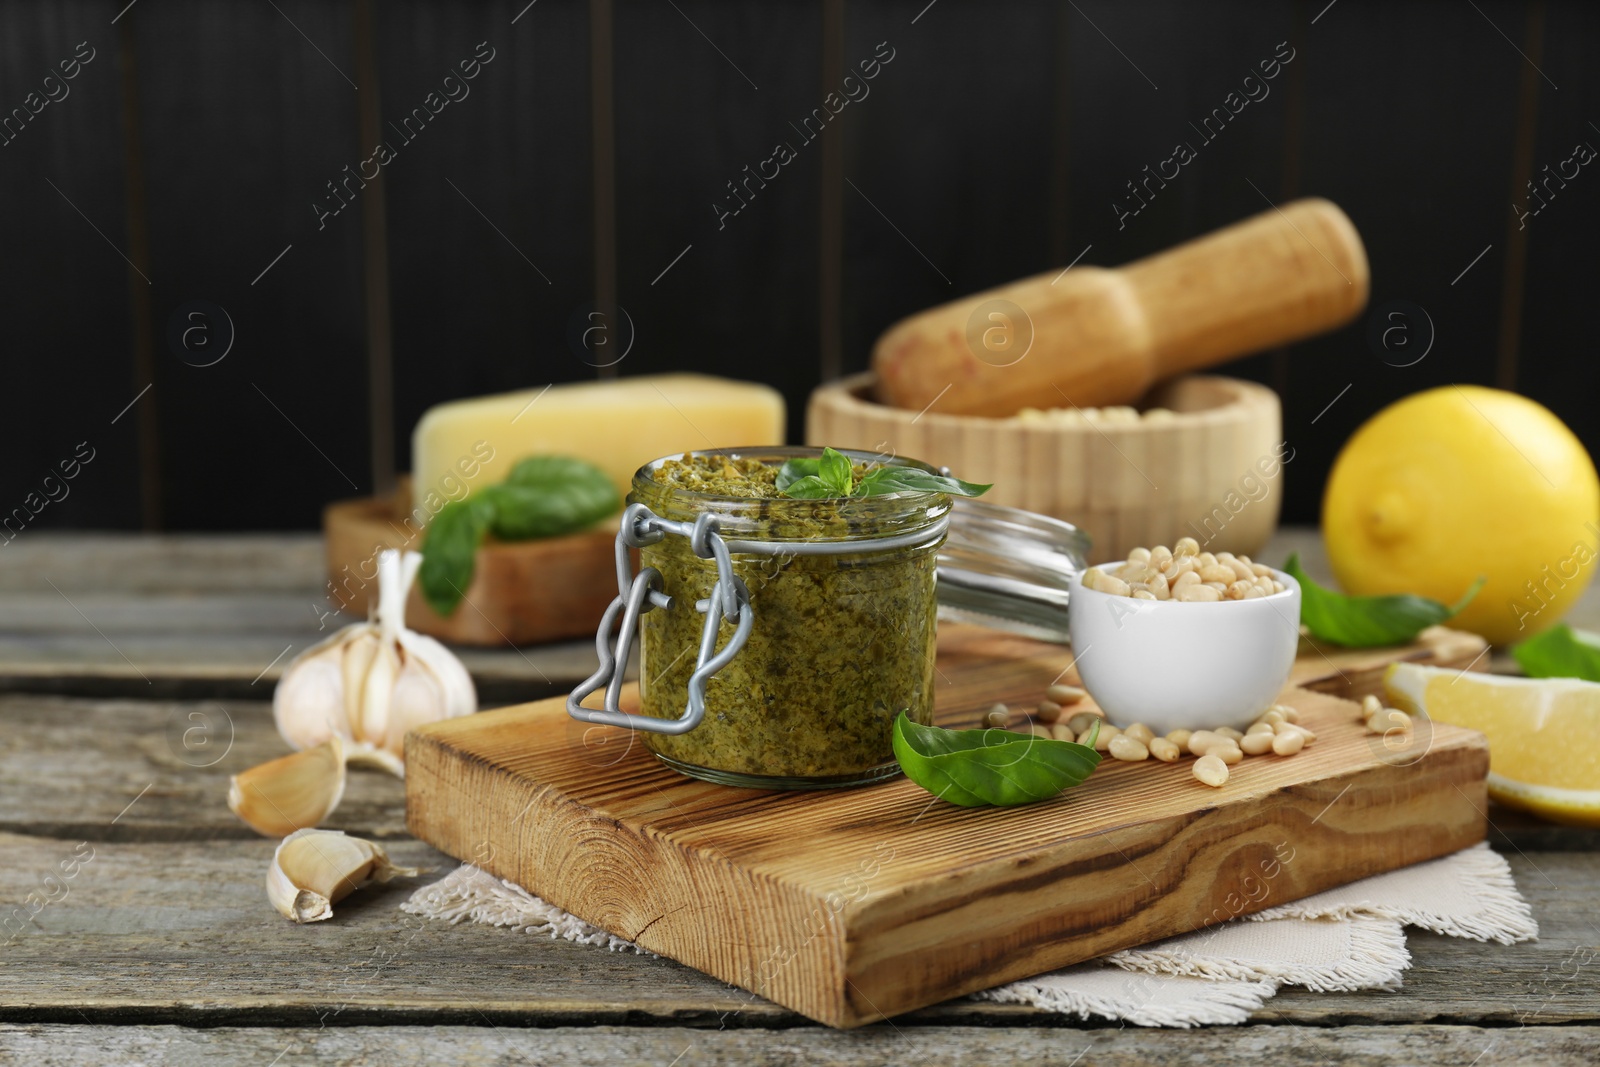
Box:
(418, 456, 622, 614)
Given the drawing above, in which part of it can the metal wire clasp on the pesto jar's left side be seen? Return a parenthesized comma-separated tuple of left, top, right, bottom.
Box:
(566, 504, 755, 734)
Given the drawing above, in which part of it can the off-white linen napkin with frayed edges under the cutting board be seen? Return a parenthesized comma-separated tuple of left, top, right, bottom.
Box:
(400, 845, 1539, 1027)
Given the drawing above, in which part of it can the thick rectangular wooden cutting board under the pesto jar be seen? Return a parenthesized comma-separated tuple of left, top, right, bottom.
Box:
(406, 625, 1488, 1027)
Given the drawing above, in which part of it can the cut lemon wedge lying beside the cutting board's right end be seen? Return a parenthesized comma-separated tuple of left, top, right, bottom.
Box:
(1384, 664, 1600, 827)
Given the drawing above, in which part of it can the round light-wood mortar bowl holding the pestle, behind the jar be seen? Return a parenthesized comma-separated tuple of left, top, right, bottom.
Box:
(806, 373, 1293, 563)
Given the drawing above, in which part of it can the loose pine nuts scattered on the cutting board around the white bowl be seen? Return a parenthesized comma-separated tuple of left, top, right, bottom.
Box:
(984, 685, 1318, 789)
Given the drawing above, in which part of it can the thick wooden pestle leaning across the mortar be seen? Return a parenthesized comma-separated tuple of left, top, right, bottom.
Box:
(872, 198, 1368, 416)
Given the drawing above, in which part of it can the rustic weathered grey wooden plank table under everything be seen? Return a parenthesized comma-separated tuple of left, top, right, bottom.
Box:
(0, 531, 1600, 1067)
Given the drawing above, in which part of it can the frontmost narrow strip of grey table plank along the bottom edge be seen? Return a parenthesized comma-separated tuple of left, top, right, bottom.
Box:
(9, 1025, 1600, 1067)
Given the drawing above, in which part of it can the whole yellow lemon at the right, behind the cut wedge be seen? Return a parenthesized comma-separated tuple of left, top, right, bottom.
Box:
(1322, 386, 1600, 645)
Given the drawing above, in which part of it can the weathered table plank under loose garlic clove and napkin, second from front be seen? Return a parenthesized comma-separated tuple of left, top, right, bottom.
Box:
(0, 838, 1600, 1030)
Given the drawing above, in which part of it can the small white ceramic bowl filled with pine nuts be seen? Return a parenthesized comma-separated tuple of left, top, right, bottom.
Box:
(1067, 563, 1301, 734)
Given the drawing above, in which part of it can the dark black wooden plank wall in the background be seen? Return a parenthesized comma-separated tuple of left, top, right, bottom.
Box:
(0, 0, 1600, 530)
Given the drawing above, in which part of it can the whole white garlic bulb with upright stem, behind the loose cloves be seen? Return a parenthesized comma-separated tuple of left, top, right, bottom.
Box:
(272, 549, 478, 774)
